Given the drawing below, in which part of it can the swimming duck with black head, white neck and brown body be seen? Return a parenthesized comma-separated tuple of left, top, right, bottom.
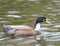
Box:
(3, 17, 49, 37)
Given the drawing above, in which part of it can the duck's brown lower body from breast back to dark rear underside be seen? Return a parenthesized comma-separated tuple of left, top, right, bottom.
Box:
(9, 28, 39, 38)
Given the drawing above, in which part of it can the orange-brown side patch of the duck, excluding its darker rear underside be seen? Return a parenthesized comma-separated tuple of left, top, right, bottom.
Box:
(15, 29, 38, 35)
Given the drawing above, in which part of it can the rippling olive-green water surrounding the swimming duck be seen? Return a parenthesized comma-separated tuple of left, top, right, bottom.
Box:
(0, 0, 60, 46)
